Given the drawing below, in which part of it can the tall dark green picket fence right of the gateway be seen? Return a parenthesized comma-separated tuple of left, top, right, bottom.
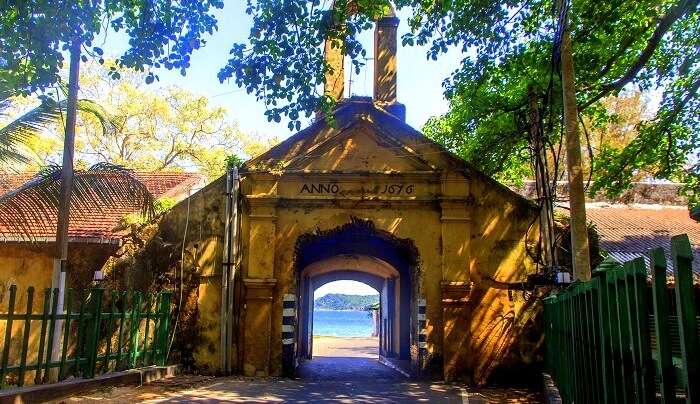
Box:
(544, 235, 700, 403)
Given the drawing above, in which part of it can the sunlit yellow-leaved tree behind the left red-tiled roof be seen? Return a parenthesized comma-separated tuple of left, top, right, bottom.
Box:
(77, 65, 257, 178)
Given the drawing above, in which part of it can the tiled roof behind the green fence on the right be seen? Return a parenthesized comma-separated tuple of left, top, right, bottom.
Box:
(586, 204, 700, 276)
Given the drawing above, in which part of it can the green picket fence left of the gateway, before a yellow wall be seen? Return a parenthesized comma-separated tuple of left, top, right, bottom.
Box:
(0, 285, 172, 388)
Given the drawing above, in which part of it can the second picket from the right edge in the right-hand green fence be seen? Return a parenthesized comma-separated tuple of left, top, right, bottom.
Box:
(651, 248, 676, 404)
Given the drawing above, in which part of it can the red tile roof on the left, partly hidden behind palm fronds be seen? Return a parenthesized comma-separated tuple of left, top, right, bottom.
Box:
(0, 172, 205, 243)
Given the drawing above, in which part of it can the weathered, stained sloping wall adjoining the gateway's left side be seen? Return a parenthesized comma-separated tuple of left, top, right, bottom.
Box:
(142, 178, 225, 373)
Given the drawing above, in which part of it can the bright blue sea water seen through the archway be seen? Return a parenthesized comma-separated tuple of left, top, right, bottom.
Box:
(314, 310, 374, 337)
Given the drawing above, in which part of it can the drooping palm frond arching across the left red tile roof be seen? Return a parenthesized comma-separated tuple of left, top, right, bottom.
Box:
(0, 163, 154, 241)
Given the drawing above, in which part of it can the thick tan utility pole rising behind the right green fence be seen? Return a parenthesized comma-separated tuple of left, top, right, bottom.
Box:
(558, 0, 591, 281)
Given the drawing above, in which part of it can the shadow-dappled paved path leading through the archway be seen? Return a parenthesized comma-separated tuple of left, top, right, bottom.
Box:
(53, 338, 540, 404)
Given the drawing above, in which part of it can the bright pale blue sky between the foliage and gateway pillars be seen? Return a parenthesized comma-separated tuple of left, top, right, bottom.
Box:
(104, 1, 461, 143)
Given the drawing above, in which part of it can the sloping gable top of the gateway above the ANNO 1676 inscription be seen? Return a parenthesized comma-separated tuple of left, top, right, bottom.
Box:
(242, 97, 529, 204)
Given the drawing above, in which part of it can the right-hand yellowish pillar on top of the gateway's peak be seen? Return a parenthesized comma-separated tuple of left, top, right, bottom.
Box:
(374, 7, 406, 120)
